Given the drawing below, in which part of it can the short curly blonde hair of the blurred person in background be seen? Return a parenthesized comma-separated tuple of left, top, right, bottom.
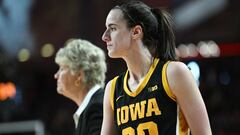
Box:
(55, 39, 107, 86)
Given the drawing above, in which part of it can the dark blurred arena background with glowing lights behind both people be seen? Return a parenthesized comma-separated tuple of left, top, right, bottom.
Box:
(0, 0, 240, 135)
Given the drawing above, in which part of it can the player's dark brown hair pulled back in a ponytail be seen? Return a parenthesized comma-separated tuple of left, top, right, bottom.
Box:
(113, 0, 178, 61)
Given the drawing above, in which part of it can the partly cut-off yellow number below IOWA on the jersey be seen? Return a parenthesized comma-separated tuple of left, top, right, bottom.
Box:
(122, 121, 158, 135)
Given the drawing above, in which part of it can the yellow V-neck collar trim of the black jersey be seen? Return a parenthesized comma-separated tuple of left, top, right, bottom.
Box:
(123, 58, 159, 97)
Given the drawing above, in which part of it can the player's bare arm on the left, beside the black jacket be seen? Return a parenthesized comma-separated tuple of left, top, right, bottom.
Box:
(101, 81, 117, 135)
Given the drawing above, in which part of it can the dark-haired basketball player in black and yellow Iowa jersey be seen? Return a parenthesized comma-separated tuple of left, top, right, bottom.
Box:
(101, 1, 212, 135)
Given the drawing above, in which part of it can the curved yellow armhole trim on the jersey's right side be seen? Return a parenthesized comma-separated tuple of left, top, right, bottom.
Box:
(162, 61, 176, 101)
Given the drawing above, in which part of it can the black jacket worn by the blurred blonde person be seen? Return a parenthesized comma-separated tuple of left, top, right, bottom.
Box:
(75, 88, 104, 135)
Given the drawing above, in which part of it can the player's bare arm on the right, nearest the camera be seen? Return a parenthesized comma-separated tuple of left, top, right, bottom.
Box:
(167, 62, 212, 135)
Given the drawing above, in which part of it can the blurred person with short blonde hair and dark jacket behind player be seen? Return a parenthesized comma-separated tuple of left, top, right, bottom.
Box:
(54, 39, 107, 135)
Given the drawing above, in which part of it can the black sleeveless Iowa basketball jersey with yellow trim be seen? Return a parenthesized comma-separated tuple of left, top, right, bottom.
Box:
(110, 59, 189, 135)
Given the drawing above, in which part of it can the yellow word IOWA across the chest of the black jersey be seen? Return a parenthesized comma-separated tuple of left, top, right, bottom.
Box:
(117, 98, 161, 125)
